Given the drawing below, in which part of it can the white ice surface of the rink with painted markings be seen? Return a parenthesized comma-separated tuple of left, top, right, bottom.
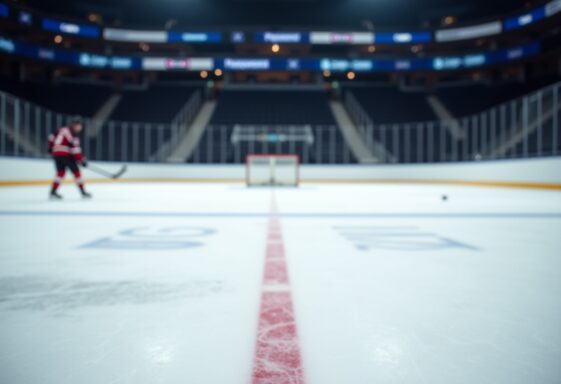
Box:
(0, 183, 561, 384)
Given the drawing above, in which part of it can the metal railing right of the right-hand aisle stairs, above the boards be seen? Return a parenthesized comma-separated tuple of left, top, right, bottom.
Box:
(345, 83, 561, 163)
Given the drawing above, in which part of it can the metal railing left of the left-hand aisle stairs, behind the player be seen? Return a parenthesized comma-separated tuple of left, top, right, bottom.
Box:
(0, 92, 201, 162)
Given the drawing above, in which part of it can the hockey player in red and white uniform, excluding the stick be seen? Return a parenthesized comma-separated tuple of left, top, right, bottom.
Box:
(49, 120, 92, 200)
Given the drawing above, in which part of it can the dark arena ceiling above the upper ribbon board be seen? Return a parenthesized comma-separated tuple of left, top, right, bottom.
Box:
(18, 0, 540, 29)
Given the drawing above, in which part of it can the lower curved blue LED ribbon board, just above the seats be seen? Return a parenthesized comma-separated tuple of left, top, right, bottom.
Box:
(0, 36, 541, 72)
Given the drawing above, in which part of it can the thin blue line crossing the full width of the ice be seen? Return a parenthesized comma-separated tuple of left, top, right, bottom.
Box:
(0, 211, 561, 219)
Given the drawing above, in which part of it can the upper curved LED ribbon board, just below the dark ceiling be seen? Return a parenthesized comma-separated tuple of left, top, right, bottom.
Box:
(0, 0, 561, 45)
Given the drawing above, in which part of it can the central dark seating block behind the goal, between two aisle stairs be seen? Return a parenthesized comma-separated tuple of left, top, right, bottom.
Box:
(188, 90, 354, 163)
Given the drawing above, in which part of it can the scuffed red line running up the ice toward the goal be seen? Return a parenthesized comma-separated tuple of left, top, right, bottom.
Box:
(252, 195, 304, 384)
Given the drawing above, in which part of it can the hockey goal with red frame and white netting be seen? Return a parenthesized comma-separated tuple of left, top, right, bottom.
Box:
(246, 155, 300, 186)
